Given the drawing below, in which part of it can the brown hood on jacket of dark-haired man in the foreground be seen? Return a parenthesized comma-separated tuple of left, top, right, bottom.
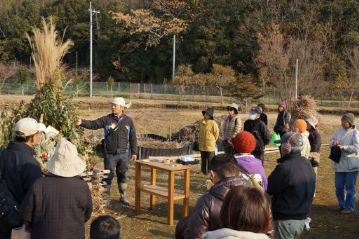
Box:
(209, 175, 249, 201)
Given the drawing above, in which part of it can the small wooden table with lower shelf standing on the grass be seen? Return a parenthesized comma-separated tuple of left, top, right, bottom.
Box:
(135, 160, 190, 225)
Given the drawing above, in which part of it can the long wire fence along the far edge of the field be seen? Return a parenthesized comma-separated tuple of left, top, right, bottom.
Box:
(0, 81, 359, 107)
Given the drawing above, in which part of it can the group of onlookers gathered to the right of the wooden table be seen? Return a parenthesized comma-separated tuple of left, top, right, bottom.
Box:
(183, 102, 359, 239)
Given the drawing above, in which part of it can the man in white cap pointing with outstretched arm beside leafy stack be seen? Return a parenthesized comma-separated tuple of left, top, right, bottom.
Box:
(77, 97, 137, 206)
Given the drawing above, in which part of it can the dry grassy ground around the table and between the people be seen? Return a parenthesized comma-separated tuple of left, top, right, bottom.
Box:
(78, 108, 359, 239)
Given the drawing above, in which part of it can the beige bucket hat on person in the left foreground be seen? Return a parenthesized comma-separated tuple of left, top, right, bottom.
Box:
(47, 138, 86, 177)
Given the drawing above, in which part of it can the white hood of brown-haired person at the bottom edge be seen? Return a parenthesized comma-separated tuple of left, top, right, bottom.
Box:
(203, 228, 269, 239)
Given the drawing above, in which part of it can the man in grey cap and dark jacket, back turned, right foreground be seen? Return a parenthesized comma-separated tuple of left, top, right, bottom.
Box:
(267, 132, 315, 239)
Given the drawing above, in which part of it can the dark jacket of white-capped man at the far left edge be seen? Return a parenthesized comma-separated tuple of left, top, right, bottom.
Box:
(0, 142, 42, 204)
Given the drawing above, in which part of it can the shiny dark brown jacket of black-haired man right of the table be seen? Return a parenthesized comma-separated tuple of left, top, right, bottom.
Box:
(176, 176, 248, 238)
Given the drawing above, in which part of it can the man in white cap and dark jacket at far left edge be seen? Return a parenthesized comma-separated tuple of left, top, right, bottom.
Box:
(0, 118, 42, 239)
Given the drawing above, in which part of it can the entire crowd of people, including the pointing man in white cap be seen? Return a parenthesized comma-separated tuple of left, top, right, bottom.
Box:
(0, 97, 359, 239)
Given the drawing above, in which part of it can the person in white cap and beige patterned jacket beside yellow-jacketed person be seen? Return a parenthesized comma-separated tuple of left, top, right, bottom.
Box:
(222, 103, 242, 155)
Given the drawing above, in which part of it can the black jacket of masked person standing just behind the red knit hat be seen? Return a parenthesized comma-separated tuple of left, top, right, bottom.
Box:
(243, 118, 271, 156)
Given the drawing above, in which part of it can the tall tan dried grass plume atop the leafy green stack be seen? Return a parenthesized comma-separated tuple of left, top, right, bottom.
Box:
(27, 18, 73, 91)
